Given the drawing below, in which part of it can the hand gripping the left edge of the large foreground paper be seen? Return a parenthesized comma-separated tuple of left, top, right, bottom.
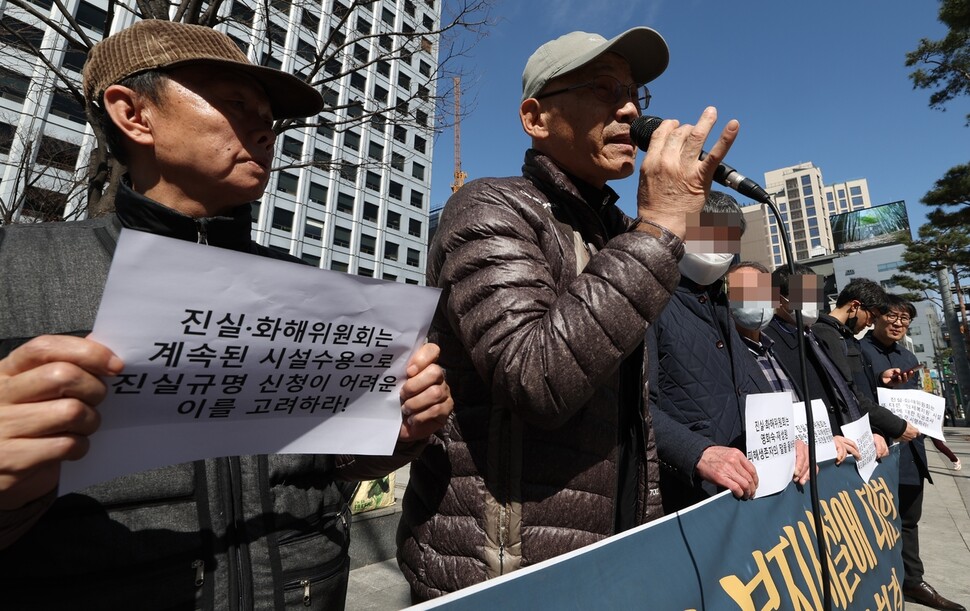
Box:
(0, 335, 123, 510)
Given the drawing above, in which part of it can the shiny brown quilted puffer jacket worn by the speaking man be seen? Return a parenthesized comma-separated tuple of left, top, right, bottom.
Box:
(398, 151, 683, 599)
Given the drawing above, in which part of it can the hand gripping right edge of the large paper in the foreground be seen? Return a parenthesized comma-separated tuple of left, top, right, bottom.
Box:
(398, 344, 455, 441)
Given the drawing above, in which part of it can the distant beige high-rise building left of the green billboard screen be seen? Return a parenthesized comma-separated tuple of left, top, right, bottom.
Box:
(742, 161, 872, 267)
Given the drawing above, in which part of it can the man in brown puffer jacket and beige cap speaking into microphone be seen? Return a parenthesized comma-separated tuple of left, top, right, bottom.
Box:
(398, 27, 738, 602)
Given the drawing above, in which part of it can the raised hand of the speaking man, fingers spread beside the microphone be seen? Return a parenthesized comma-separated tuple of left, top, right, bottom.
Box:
(637, 106, 740, 237)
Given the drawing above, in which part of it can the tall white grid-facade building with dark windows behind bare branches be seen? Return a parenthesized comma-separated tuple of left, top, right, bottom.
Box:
(0, 0, 441, 284)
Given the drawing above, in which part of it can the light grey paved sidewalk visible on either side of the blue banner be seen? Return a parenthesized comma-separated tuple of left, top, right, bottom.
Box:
(347, 427, 970, 611)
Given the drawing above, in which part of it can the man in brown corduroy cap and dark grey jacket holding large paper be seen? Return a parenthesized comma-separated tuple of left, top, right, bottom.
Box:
(0, 21, 452, 610)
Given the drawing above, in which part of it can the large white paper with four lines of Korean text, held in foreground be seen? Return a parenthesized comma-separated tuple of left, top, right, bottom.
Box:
(60, 230, 440, 494)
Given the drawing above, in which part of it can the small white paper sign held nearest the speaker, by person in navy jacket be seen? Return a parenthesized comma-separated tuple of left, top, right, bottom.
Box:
(744, 392, 795, 499)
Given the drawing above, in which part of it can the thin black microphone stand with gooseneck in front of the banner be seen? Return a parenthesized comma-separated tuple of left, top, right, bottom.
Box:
(758, 194, 832, 609)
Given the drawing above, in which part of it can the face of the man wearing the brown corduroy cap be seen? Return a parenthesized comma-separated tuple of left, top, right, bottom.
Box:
(143, 65, 276, 216)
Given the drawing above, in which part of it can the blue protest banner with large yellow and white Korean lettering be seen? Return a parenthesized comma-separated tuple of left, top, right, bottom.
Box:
(420, 446, 903, 611)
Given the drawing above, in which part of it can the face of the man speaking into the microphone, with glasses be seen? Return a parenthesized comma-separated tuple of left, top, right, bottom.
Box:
(535, 53, 640, 187)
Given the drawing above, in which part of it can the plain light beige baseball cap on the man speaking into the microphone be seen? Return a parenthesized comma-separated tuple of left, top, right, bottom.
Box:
(522, 27, 670, 100)
